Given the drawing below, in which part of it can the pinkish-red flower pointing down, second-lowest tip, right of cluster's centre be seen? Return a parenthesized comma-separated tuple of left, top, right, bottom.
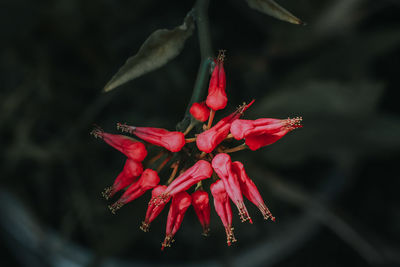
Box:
(210, 180, 236, 246)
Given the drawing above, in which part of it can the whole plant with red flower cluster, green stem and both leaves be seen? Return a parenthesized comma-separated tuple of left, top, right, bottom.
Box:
(91, 0, 304, 253)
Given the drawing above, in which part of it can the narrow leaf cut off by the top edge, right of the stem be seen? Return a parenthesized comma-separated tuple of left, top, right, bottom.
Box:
(246, 0, 305, 25)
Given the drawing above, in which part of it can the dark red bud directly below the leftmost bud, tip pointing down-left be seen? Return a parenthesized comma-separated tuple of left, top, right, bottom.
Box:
(102, 158, 143, 199)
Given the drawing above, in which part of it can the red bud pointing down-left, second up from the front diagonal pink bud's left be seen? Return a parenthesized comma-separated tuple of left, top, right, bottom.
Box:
(109, 169, 160, 213)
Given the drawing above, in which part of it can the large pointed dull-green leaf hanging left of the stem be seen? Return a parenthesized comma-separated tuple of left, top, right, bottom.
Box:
(104, 13, 194, 92)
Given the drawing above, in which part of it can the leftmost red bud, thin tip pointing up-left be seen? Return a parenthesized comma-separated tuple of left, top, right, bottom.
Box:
(91, 128, 147, 162)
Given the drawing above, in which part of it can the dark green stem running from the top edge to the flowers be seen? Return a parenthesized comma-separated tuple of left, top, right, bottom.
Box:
(176, 0, 213, 132)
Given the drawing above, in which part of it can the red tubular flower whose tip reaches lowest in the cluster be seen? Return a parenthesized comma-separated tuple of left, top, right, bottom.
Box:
(161, 192, 192, 250)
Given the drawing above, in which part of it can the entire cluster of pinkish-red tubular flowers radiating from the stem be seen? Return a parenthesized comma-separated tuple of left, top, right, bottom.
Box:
(91, 51, 302, 250)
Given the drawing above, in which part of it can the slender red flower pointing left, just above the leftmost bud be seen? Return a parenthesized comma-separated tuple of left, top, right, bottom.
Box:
(117, 123, 186, 152)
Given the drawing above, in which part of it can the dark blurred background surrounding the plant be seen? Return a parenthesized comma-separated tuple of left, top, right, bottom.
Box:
(0, 0, 400, 267)
